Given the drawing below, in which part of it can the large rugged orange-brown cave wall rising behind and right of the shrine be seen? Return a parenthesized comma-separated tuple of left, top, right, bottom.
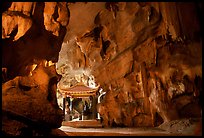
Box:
(58, 2, 202, 126)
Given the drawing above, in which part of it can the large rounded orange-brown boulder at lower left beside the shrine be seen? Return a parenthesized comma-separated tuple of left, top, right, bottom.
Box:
(2, 65, 63, 135)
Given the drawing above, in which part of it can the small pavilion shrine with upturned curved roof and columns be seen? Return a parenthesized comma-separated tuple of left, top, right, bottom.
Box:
(58, 83, 100, 121)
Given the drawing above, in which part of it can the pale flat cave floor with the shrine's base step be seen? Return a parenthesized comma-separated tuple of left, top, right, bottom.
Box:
(59, 120, 196, 136)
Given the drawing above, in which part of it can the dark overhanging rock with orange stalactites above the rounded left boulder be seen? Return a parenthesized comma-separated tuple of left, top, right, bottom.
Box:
(2, 2, 69, 80)
